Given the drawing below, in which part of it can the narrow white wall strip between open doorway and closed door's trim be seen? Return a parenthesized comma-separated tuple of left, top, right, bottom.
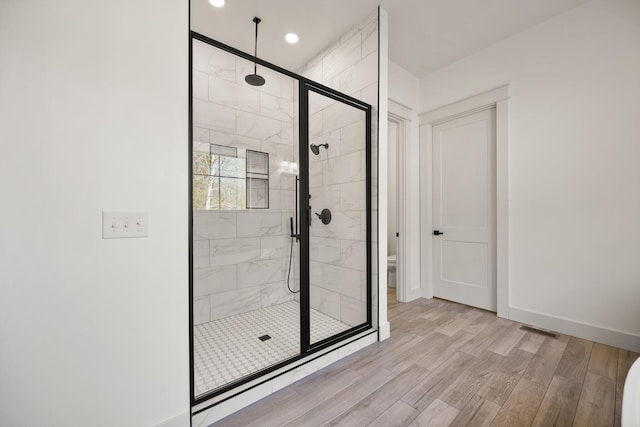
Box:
(389, 61, 422, 302)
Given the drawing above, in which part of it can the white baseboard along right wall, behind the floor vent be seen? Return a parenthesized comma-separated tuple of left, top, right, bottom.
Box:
(509, 307, 640, 353)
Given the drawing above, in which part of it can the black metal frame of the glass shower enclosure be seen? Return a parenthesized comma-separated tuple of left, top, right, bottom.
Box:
(188, 31, 373, 412)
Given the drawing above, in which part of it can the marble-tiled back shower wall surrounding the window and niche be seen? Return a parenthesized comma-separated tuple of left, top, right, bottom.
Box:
(193, 41, 298, 324)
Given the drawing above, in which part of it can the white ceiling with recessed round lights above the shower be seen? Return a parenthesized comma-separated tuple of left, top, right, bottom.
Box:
(191, 0, 588, 77)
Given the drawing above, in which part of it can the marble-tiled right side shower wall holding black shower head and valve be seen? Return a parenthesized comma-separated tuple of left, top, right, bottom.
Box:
(300, 12, 378, 326)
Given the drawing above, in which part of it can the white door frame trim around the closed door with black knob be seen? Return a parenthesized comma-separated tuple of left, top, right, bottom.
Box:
(420, 84, 510, 319)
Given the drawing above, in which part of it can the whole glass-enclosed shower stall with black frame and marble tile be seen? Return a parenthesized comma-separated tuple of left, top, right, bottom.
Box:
(190, 30, 374, 403)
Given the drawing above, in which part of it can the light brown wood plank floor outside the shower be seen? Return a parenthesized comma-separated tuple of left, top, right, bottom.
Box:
(214, 293, 638, 427)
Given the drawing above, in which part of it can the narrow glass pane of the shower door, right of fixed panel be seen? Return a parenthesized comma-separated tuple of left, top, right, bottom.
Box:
(308, 91, 368, 346)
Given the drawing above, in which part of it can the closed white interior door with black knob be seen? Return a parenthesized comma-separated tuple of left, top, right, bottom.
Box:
(433, 109, 497, 311)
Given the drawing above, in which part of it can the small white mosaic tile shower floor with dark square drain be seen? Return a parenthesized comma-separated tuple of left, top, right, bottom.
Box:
(193, 301, 350, 396)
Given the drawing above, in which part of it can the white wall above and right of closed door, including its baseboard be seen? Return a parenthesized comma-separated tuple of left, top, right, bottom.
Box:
(420, 0, 640, 351)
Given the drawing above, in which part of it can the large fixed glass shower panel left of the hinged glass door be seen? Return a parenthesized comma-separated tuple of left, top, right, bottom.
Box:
(192, 40, 301, 399)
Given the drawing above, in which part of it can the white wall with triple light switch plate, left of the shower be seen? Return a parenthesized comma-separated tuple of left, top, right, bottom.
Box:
(0, 0, 189, 426)
